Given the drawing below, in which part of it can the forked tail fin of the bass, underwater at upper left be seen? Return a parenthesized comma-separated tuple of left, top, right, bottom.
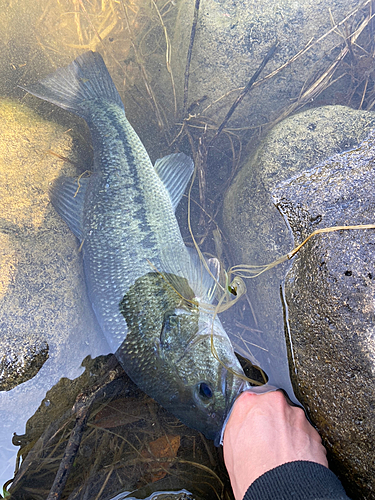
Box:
(22, 51, 123, 118)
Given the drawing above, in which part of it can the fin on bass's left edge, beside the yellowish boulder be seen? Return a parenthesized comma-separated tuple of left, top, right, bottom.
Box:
(50, 177, 89, 241)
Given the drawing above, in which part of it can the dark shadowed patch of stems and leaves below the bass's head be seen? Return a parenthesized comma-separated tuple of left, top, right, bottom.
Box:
(8, 356, 229, 500)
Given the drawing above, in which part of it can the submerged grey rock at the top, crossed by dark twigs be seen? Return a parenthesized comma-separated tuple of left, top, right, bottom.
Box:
(172, 0, 358, 131)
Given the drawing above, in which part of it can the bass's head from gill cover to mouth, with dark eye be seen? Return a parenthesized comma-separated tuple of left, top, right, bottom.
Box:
(159, 309, 247, 439)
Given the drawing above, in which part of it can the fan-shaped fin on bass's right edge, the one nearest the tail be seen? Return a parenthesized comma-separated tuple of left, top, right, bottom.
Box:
(155, 153, 194, 210)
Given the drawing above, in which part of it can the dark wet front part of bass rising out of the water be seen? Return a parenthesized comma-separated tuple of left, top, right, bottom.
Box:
(116, 273, 247, 439)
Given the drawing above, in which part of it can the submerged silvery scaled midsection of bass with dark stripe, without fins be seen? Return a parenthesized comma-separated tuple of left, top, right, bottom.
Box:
(76, 101, 189, 350)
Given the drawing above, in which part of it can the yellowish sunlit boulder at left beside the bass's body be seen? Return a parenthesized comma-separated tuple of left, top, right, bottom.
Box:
(0, 101, 105, 390)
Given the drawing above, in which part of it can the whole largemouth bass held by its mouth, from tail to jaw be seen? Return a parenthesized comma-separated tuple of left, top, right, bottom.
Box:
(25, 52, 244, 438)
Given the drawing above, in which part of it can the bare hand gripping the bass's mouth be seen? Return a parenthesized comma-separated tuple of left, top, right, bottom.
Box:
(223, 391, 328, 500)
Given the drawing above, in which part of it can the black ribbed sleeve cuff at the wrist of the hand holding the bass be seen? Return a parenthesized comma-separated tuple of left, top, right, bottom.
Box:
(243, 461, 349, 500)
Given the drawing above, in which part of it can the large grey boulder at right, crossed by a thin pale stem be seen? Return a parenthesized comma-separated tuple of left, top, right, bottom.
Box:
(224, 106, 375, 498)
